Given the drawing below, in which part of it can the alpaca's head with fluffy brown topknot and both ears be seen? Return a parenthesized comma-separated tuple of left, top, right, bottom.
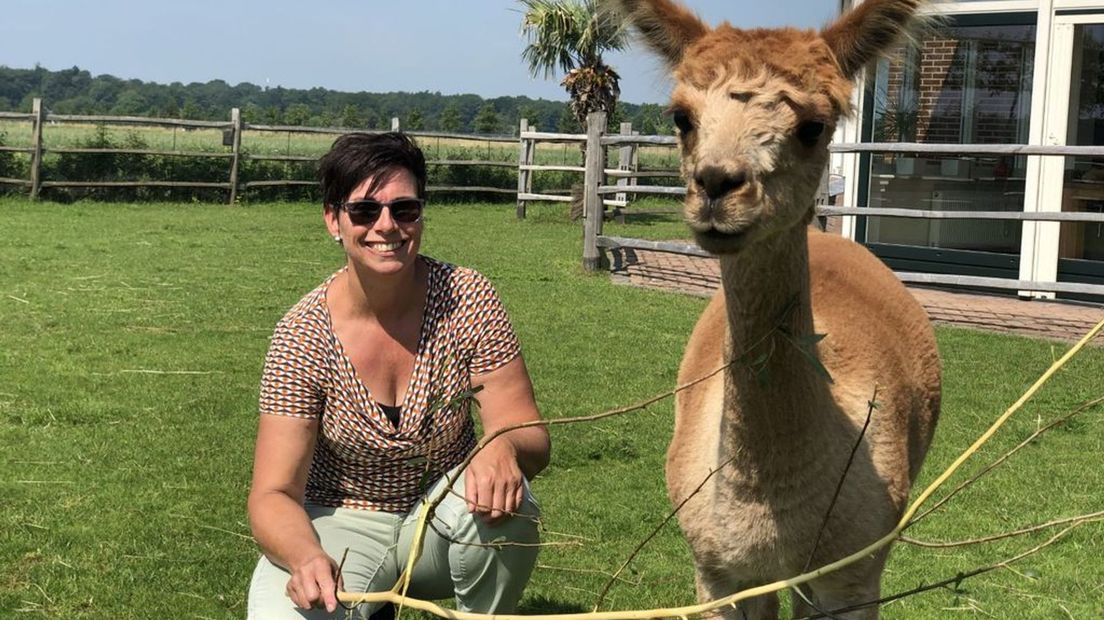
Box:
(614, 0, 922, 254)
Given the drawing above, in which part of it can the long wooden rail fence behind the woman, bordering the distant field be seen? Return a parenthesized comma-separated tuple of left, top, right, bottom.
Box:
(0, 98, 529, 204)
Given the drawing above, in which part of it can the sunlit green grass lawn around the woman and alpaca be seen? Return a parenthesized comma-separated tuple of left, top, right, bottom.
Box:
(0, 200, 1104, 619)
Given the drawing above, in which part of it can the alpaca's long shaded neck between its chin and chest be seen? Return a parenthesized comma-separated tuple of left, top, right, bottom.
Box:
(721, 225, 828, 449)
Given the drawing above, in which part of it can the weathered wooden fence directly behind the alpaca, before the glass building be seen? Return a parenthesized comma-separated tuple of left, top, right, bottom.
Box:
(565, 113, 1104, 296)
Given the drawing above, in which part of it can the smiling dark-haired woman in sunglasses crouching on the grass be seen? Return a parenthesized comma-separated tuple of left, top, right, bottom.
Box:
(248, 133, 550, 620)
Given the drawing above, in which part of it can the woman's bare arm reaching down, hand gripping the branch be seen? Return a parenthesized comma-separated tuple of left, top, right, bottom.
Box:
(248, 414, 337, 612)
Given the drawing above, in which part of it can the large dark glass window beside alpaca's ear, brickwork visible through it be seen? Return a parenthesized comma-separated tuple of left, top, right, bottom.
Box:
(866, 21, 1036, 254)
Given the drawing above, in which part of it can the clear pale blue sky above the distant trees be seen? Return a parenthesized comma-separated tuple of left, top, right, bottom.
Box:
(0, 0, 838, 103)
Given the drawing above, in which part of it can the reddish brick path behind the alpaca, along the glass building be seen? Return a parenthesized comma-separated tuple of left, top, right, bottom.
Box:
(609, 244, 1104, 345)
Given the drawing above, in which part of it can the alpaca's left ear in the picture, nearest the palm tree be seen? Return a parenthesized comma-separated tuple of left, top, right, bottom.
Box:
(606, 0, 709, 67)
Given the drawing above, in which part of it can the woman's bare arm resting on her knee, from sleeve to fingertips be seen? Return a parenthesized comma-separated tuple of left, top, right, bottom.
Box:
(465, 355, 551, 523)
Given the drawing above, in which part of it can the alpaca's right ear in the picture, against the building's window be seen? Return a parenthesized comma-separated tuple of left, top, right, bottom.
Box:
(821, 0, 923, 77)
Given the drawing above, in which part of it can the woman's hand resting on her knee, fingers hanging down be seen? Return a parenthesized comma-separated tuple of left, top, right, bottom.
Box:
(464, 436, 526, 524)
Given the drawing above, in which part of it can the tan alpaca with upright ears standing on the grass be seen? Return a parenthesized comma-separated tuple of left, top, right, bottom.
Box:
(616, 0, 941, 619)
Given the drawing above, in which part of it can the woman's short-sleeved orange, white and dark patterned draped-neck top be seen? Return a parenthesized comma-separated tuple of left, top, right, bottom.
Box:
(261, 256, 520, 512)
